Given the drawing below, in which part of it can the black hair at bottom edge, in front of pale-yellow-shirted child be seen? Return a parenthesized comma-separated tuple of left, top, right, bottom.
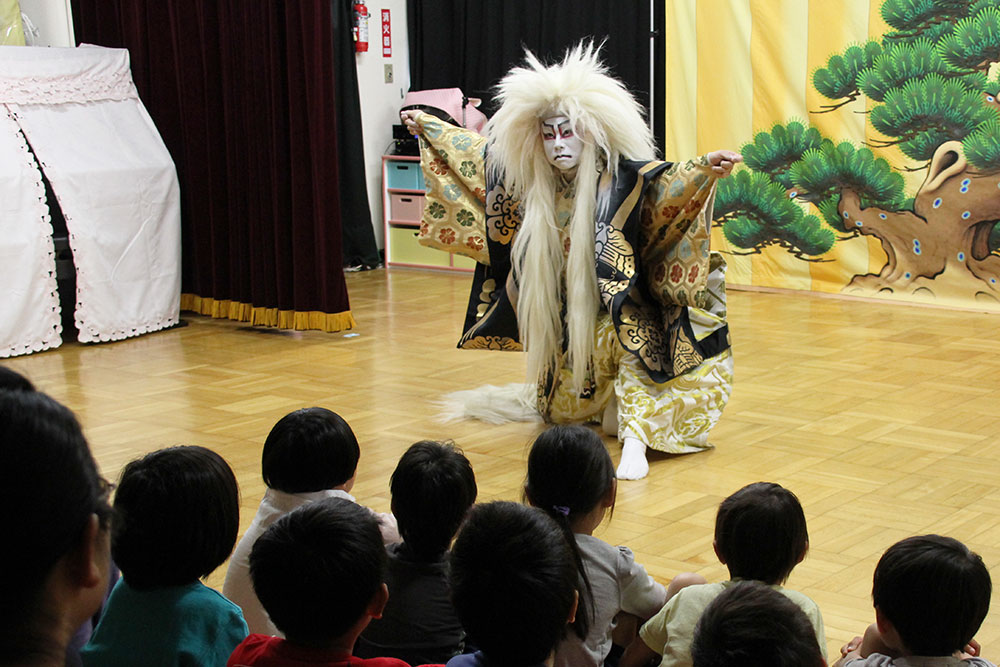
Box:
(691, 581, 826, 667)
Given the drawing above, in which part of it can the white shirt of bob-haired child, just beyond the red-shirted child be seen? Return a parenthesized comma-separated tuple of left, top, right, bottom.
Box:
(222, 489, 400, 637)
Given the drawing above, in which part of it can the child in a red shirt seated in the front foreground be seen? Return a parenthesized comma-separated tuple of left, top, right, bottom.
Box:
(228, 498, 406, 667)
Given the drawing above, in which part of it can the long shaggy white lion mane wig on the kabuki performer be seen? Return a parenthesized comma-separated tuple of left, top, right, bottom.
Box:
(486, 42, 656, 391)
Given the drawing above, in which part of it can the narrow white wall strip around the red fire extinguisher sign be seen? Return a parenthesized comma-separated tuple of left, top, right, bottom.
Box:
(355, 0, 410, 248)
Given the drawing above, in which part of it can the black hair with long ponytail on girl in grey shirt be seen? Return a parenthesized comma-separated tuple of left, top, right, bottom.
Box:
(524, 426, 615, 639)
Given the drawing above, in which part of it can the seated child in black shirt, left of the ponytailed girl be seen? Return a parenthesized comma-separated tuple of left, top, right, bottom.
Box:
(354, 440, 476, 665)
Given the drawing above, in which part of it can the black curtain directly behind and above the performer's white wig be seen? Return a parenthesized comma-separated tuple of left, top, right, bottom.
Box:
(406, 0, 663, 146)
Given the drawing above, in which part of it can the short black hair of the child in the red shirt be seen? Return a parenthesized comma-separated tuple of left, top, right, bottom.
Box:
(250, 498, 386, 647)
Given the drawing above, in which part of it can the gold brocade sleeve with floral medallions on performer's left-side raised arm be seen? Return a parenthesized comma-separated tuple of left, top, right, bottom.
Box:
(416, 113, 489, 264)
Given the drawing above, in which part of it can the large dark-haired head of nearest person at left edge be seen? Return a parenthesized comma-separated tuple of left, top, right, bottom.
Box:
(0, 388, 111, 666)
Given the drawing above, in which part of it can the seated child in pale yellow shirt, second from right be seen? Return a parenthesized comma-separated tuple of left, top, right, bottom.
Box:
(621, 482, 826, 667)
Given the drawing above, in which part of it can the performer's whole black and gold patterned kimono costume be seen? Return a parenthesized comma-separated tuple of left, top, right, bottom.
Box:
(410, 114, 732, 460)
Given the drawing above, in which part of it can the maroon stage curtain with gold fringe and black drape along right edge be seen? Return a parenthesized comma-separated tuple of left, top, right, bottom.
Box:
(72, 0, 374, 331)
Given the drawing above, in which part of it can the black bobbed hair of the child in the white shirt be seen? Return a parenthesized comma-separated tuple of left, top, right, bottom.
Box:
(261, 408, 361, 493)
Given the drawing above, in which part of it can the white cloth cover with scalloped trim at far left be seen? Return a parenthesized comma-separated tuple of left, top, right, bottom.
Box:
(0, 46, 181, 357)
